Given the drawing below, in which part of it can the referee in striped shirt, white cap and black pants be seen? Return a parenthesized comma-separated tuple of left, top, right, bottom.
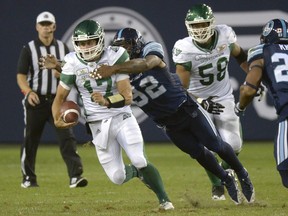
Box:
(17, 11, 88, 188)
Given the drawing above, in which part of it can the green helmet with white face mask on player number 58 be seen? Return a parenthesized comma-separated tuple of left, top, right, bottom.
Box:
(185, 4, 215, 43)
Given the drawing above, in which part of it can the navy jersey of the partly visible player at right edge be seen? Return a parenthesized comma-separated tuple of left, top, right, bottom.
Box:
(248, 44, 288, 120)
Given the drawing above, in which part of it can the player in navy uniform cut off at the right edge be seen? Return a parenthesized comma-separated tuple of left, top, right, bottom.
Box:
(235, 19, 288, 188)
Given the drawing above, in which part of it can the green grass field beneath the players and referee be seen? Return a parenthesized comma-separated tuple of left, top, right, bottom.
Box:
(0, 142, 288, 216)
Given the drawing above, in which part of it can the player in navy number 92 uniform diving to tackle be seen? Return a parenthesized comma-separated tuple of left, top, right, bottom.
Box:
(91, 28, 255, 204)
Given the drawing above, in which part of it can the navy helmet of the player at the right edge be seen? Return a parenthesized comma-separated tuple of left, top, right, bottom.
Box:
(260, 19, 288, 44)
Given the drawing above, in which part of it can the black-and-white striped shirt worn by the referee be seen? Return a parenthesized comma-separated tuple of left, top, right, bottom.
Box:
(17, 39, 69, 95)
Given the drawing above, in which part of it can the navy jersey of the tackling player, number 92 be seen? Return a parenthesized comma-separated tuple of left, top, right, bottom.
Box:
(130, 42, 194, 120)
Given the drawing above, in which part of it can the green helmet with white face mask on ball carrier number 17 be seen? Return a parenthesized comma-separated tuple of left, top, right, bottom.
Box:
(72, 20, 105, 61)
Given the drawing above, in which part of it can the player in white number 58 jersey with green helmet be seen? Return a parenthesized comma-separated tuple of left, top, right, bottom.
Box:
(173, 4, 248, 200)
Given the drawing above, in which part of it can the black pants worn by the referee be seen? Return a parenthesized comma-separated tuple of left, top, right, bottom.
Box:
(21, 96, 83, 182)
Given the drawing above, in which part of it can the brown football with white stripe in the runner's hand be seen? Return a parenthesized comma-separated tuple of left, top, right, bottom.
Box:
(60, 101, 81, 123)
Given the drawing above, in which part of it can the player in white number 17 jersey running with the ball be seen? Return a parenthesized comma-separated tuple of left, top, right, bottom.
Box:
(52, 20, 174, 210)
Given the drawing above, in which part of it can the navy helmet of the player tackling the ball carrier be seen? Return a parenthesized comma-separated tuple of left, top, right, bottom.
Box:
(112, 28, 145, 59)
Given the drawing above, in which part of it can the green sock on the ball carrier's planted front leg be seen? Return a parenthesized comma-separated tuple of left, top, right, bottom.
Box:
(139, 163, 170, 203)
